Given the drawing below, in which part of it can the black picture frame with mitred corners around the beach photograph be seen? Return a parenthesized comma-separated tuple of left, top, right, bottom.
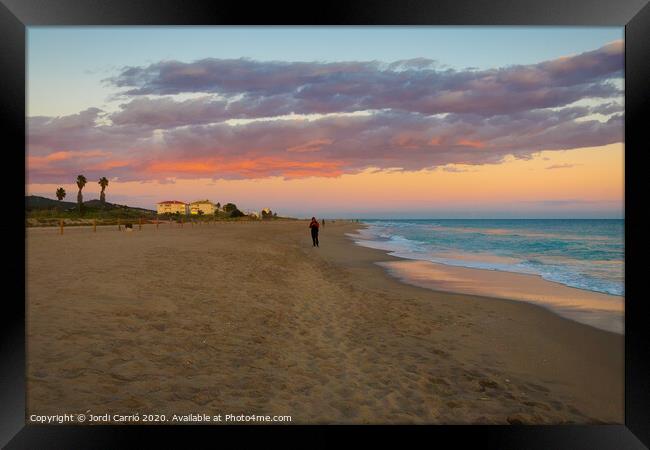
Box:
(0, 0, 650, 449)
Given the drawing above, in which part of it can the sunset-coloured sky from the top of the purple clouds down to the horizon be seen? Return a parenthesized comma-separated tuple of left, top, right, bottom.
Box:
(26, 29, 624, 218)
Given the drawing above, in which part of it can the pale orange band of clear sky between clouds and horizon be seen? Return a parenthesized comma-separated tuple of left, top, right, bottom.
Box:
(27, 144, 624, 214)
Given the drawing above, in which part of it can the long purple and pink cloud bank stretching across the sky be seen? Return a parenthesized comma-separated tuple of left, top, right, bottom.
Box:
(27, 42, 623, 182)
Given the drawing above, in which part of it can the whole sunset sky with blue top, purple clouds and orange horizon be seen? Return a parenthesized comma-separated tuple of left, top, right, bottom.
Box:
(26, 27, 624, 218)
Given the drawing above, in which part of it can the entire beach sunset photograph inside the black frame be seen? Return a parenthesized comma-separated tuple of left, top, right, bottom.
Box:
(25, 26, 625, 426)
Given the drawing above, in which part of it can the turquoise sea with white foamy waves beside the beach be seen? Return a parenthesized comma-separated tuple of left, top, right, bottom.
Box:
(357, 219, 625, 295)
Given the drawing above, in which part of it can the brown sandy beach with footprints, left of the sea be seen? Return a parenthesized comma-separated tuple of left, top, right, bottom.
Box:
(26, 221, 624, 424)
